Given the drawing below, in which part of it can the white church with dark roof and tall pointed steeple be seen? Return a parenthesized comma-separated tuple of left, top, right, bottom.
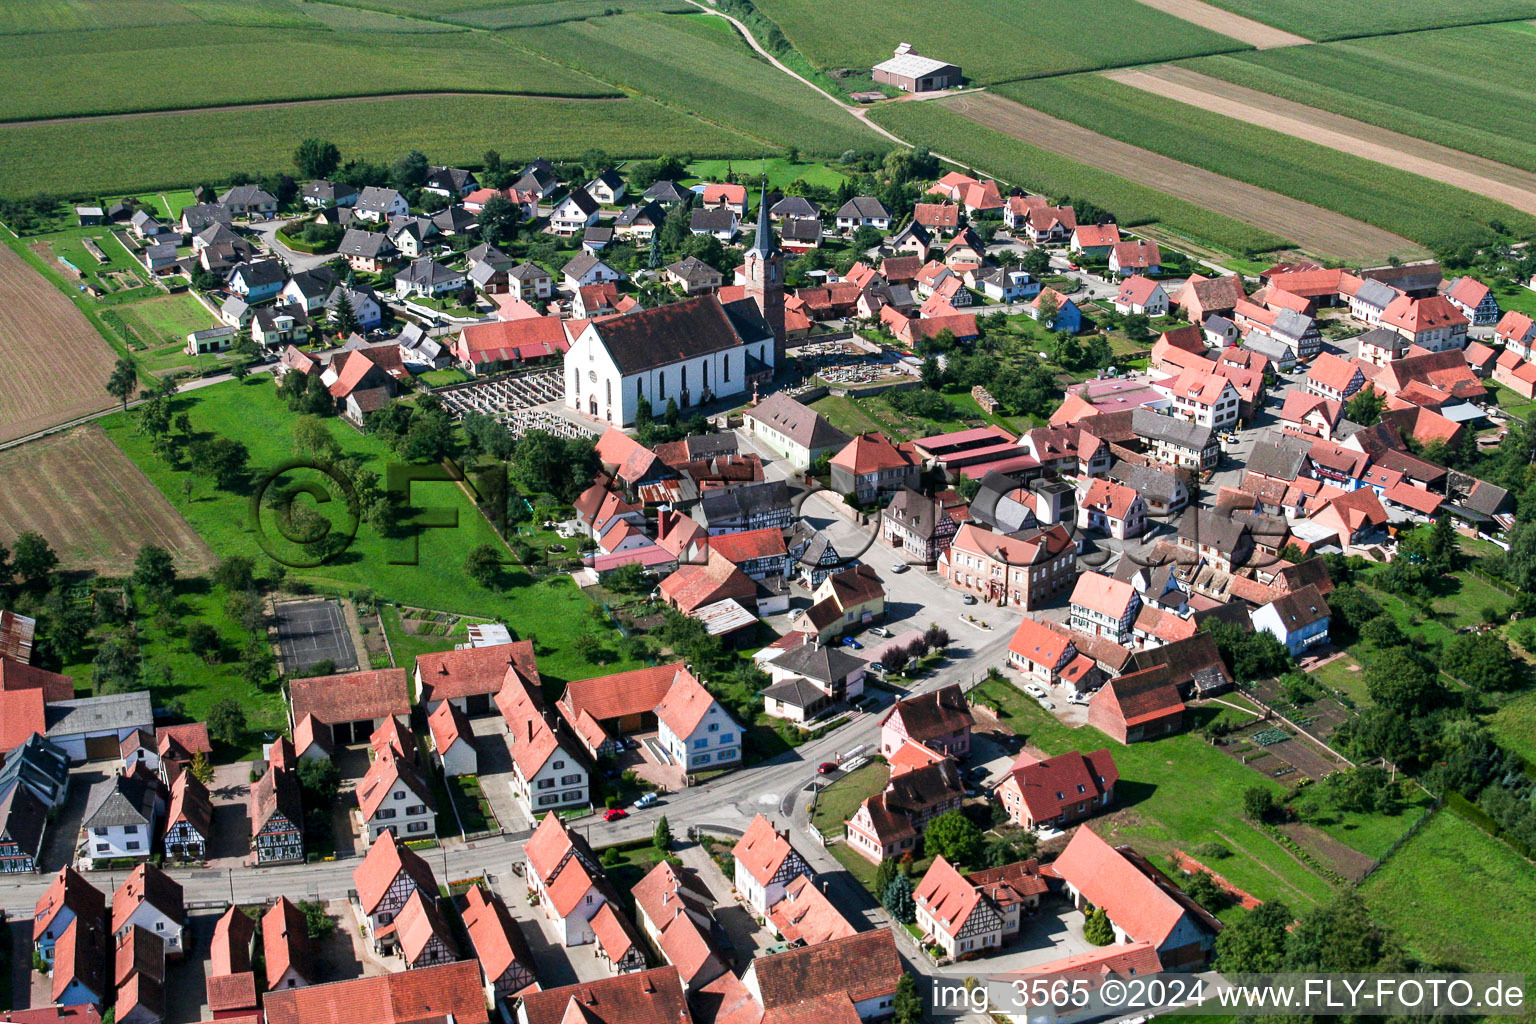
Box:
(564, 183, 783, 427)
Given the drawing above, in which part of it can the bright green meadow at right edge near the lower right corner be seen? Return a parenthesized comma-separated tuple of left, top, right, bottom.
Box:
(1362, 811, 1536, 975)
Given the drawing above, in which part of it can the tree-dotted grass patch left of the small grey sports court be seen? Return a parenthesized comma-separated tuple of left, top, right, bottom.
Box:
(65, 577, 287, 761)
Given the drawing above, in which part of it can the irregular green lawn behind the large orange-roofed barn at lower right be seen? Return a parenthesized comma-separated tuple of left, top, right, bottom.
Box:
(974, 680, 1330, 907)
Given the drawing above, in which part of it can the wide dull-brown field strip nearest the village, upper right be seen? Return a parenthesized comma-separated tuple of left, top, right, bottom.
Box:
(940, 92, 1425, 264)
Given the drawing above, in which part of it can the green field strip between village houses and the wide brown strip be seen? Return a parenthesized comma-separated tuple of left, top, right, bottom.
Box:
(869, 101, 1289, 253)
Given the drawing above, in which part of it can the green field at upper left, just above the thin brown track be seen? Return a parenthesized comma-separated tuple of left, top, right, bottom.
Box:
(0, 29, 614, 120)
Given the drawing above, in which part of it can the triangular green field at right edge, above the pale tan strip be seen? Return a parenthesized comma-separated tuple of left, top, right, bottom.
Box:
(1186, 21, 1536, 170)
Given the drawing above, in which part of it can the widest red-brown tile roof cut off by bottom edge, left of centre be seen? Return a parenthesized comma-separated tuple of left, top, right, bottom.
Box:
(264, 960, 488, 1024)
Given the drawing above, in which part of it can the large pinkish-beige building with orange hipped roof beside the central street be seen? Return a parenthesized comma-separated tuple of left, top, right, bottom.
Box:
(938, 524, 1077, 611)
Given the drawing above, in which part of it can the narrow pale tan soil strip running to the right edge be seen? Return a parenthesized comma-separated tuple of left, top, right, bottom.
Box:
(1104, 66, 1536, 213)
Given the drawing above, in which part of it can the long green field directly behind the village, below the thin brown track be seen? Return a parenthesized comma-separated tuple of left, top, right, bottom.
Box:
(0, 97, 771, 195)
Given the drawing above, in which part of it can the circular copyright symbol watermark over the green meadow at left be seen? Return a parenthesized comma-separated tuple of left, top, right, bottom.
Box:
(249, 459, 358, 570)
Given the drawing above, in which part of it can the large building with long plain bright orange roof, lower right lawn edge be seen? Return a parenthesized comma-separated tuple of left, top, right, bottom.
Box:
(1051, 827, 1221, 970)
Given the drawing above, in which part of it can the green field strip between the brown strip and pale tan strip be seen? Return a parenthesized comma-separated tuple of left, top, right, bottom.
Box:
(998, 75, 1536, 249)
